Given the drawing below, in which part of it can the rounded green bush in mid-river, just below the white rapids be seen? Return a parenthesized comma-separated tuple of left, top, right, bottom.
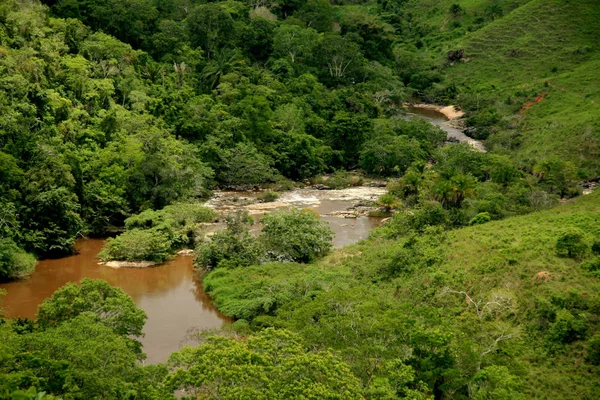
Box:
(261, 209, 333, 262)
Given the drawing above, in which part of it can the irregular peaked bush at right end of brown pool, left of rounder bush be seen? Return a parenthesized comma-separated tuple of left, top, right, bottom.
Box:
(195, 211, 261, 269)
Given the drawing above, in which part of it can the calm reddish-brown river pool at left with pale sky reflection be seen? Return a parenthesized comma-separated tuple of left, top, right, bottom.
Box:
(0, 239, 229, 363)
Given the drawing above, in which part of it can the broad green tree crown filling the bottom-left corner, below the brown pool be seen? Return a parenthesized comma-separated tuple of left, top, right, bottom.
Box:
(15, 311, 137, 398)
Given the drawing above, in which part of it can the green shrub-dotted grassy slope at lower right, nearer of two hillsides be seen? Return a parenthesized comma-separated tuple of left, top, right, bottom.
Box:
(204, 192, 600, 399)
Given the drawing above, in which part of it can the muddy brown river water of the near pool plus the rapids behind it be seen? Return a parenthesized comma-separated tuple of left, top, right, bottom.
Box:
(0, 187, 385, 363)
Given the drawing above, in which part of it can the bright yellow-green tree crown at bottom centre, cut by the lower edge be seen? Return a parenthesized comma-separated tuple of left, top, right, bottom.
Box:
(166, 329, 363, 399)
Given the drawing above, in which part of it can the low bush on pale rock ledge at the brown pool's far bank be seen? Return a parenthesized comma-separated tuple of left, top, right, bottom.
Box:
(98, 228, 172, 262)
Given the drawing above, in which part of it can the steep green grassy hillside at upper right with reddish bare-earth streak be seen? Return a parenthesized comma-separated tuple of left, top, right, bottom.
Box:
(446, 0, 600, 177)
